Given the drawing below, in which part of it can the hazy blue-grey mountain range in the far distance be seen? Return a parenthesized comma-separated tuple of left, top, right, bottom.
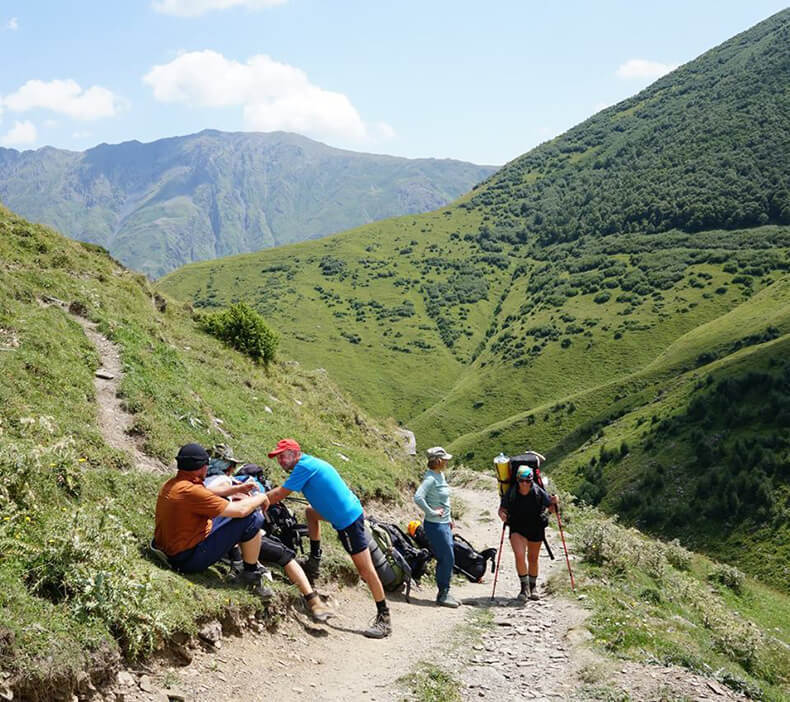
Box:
(0, 130, 496, 277)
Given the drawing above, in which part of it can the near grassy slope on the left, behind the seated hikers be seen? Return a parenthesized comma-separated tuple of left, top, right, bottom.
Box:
(0, 208, 418, 699)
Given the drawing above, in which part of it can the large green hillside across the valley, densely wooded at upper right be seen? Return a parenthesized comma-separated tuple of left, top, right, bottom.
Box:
(161, 10, 790, 582)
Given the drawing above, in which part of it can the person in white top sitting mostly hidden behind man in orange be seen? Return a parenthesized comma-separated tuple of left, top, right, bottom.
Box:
(205, 444, 332, 622)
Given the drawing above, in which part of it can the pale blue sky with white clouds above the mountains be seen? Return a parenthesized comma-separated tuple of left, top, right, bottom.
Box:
(0, 0, 784, 164)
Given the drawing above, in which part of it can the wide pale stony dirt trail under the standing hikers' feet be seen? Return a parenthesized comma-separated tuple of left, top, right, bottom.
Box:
(115, 477, 746, 702)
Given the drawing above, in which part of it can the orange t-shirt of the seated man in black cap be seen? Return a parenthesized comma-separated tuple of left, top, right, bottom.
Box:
(154, 470, 228, 556)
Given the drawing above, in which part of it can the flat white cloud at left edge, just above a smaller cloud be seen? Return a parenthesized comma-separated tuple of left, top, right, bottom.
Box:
(3, 79, 123, 120)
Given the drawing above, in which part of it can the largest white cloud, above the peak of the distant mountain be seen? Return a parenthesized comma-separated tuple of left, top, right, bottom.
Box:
(143, 50, 394, 141)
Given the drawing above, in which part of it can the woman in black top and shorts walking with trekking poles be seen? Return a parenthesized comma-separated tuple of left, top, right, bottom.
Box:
(499, 466, 557, 602)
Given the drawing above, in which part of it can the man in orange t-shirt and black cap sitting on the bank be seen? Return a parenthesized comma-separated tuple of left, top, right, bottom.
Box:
(154, 444, 269, 585)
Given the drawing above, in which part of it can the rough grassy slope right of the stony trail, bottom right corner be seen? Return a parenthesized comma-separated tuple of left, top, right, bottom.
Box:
(552, 503, 790, 702)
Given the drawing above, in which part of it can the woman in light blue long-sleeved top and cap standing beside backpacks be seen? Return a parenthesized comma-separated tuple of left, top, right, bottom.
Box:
(414, 446, 459, 607)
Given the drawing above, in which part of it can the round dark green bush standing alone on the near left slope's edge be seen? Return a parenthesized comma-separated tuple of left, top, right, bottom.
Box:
(200, 302, 280, 365)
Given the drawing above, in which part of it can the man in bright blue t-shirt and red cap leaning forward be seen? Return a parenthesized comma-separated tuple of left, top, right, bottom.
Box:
(267, 439, 392, 639)
